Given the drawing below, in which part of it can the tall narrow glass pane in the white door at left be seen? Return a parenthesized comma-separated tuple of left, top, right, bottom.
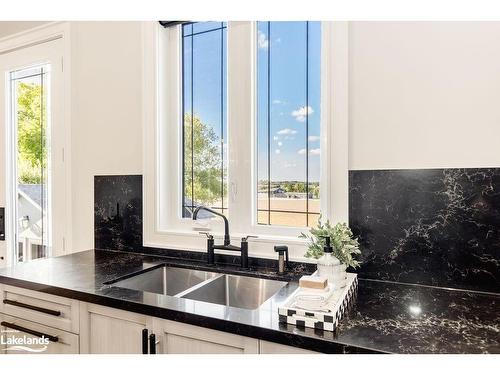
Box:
(9, 65, 50, 262)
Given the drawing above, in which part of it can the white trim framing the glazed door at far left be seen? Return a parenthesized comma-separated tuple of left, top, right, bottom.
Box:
(0, 21, 72, 265)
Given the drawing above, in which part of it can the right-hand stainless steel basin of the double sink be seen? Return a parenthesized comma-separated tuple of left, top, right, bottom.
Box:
(180, 275, 287, 310)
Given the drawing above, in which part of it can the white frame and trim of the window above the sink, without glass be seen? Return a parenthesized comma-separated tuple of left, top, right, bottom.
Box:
(142, 22, 348, 261)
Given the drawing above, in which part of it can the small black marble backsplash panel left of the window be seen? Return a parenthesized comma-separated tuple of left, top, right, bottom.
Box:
(94, 175, 142, 251)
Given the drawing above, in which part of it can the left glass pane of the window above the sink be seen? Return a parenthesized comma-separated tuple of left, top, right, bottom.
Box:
(182, 22, 227, 217)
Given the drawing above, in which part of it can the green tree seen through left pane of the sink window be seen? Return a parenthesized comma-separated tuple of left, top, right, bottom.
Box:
(184, 114, 227, 209)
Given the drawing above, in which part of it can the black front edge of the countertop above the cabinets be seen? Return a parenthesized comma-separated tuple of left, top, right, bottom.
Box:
(0, 276, 382, 354)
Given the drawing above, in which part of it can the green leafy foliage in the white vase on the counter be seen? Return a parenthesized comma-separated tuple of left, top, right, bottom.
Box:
(299, 216, 361, 270)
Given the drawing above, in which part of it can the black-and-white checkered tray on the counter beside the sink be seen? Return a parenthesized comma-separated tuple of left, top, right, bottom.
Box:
(278, 273, 358, 331)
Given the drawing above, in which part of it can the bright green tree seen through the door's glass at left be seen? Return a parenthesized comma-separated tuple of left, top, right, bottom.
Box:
(17, 82, 47, 184)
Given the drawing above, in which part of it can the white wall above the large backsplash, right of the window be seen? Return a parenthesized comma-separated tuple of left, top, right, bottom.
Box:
(349, 22, 500, 169)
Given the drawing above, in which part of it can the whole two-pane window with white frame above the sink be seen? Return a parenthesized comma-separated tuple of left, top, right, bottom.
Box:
(143, 21, 348, 250)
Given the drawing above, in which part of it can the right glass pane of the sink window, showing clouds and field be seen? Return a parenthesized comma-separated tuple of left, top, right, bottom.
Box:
(257, 22, 321, 227)
